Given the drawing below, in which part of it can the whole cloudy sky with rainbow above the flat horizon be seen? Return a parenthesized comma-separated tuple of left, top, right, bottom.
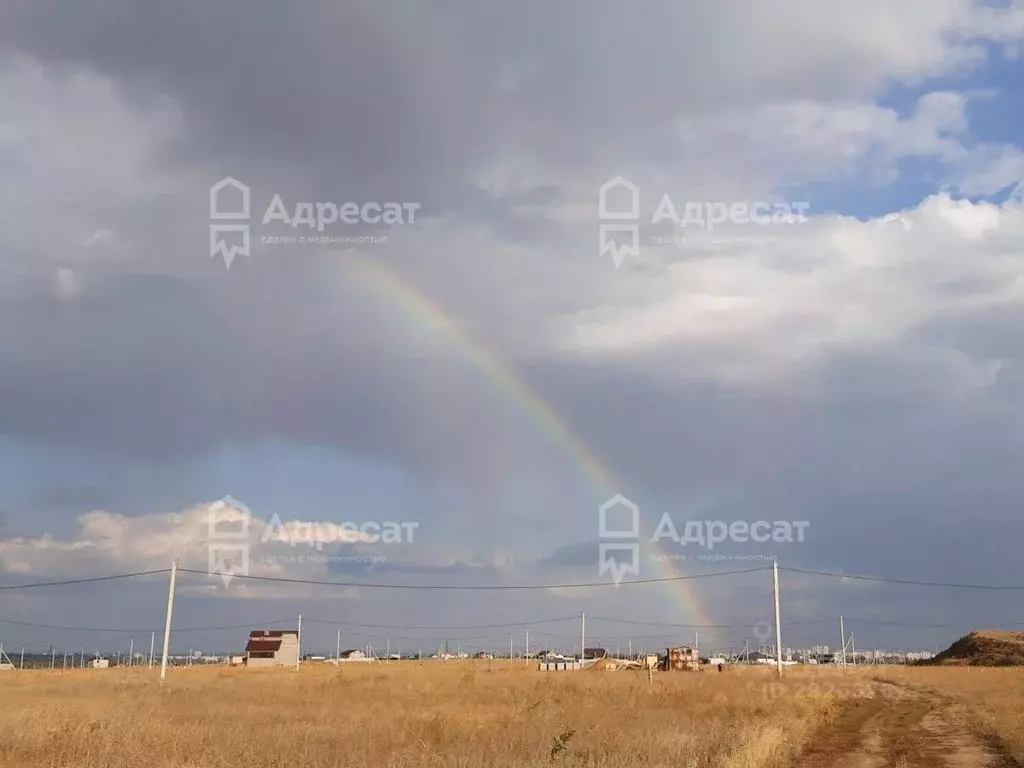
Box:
(0, 0, 1024, 652)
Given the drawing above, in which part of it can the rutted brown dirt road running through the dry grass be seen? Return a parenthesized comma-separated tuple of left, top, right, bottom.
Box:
(796, 682, 1020, 768)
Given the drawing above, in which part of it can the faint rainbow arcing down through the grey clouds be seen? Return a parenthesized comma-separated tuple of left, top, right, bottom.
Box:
(345, 252, 712, 626)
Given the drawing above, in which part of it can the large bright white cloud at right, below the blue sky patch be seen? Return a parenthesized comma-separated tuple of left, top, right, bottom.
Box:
(562, 195, 1024, 383)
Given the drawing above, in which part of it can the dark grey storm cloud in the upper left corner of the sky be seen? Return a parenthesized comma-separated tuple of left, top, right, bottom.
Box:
(2, 0, 479, 208)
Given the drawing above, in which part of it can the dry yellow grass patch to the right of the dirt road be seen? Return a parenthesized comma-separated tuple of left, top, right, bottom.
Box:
(878, 667, 1024, 764)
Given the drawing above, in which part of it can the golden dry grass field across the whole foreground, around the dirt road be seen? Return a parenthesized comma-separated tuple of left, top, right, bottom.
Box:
(0, 660, 1024, 768)
